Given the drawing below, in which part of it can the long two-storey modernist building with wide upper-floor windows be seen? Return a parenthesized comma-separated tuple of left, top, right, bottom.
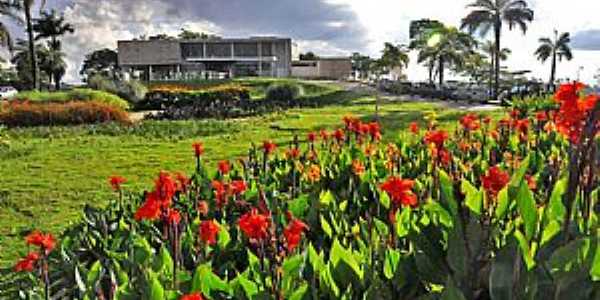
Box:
(118, 37, 294, 81)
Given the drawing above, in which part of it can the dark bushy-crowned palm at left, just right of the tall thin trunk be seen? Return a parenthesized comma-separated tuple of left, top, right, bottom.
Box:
(33, 10, 75, 91)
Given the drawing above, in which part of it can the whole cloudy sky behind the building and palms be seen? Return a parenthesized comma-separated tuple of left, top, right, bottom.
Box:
(4, 0, 600, 84)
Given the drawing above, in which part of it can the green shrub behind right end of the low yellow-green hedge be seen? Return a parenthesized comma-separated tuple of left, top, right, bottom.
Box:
(88, 75, 148, 103)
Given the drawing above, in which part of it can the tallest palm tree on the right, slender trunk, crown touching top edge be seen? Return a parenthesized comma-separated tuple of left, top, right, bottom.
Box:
(461, 0, 533, 102)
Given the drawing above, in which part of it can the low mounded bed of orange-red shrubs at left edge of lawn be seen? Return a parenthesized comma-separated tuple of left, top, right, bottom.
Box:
(0, 101, 129, 127)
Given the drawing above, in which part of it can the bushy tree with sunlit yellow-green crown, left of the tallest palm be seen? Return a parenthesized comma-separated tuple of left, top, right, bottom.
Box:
(417, 26, 477, 88)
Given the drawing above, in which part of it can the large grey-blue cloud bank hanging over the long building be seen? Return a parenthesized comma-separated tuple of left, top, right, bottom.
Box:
(54, 0, 367, 82)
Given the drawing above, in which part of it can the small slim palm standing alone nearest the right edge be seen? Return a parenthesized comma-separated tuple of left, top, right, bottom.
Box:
(535, 30, 573, 89)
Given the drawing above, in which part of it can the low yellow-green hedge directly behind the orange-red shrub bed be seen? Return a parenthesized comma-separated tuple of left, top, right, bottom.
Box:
(13, 89, 129, 110)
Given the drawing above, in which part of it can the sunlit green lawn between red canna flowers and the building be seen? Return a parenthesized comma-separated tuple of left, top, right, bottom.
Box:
(0, 91, 504, 266)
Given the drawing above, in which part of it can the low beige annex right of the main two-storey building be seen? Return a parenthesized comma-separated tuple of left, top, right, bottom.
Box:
(292, 57, 352, 80)
